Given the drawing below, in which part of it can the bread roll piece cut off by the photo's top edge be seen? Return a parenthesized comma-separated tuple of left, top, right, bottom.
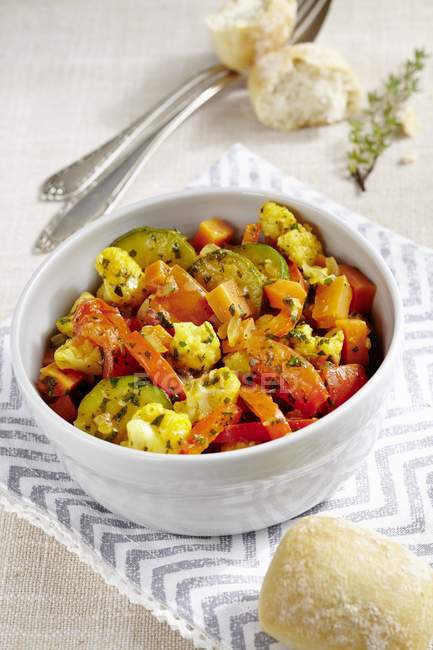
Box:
(207, 0, 296, 71)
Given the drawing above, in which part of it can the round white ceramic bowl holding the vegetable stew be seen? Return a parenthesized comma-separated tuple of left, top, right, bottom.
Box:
(12, 189, 402, 535)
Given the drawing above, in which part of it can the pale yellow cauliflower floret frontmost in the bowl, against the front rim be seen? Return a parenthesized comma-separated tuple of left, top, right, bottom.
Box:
(122, 402, 191, 454)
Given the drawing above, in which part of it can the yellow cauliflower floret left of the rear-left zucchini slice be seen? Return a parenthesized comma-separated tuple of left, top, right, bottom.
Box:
(95, 246, 144, 305)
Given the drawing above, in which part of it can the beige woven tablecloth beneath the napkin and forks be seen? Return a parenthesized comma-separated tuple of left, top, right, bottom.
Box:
(0, 0, 433, 650)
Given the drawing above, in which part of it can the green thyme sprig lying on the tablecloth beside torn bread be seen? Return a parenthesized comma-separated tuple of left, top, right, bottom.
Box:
(347, 49, 428, 192)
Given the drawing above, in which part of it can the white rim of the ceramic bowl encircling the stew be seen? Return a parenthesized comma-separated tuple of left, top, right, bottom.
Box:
(11, 187, 403, 466)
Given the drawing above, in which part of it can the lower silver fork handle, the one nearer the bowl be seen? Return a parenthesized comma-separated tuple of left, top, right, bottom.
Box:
(34, 72, 239, 253)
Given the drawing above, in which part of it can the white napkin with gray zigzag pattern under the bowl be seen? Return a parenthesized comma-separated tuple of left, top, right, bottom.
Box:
(0, 145, 433, 650)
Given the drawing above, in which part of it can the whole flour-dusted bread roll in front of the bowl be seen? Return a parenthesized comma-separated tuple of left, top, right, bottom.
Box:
(259, 517, 433, 650)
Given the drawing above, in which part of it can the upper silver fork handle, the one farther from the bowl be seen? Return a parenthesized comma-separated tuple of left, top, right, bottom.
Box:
(40, 64, 227, 201)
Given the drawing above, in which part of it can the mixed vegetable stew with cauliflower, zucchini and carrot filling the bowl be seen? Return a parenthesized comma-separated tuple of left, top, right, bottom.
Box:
(37, 201, 375, 454)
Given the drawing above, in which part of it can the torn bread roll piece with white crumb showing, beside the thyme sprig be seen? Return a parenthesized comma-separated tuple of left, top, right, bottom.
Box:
(248, 43, 362, 131)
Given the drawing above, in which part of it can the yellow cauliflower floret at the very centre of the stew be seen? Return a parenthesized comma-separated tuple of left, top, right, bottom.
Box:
(171, 321, 221, 371)
